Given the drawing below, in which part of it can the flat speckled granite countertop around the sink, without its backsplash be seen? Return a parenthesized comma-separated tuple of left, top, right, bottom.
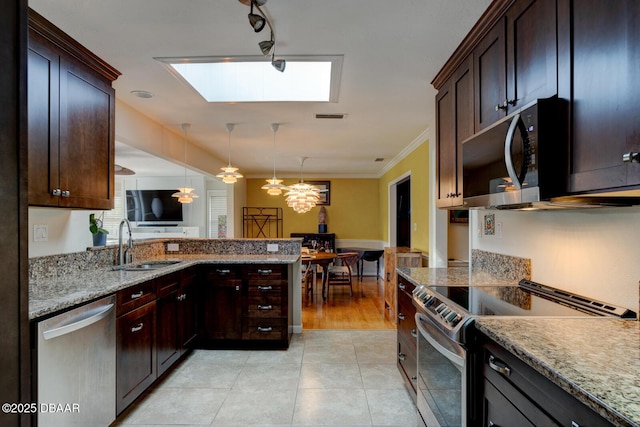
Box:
(29, 254, 300, 320)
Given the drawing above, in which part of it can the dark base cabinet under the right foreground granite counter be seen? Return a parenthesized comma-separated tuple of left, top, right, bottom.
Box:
(474, 334, 612, 427)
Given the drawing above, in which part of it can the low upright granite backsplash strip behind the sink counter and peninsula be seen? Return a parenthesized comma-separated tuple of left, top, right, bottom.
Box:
(29, 239, 302, 281)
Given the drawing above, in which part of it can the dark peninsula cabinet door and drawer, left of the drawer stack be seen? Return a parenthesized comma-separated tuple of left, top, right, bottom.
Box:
(200, 265, 242, 345)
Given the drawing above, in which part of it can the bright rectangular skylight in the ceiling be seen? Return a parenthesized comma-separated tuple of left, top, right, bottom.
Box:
(155, 56, 342, 102)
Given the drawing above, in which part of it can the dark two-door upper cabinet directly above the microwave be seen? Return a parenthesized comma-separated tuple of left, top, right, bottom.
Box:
(473, 0, 557, 132)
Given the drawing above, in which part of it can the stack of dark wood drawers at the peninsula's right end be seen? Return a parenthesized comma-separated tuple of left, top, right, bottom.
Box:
(242, 264, 292, 347)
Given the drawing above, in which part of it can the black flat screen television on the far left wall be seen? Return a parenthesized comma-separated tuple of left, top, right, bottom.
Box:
(127, 190, 182, 225)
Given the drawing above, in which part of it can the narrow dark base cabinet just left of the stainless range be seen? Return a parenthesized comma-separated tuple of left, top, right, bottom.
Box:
(396, 276, 418, 401)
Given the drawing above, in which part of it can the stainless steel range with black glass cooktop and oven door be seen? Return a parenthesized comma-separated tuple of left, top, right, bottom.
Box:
(413, 280, 636, 427)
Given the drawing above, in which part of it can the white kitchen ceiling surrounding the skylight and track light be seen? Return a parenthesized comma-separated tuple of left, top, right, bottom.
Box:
(29, 0, 490, 178)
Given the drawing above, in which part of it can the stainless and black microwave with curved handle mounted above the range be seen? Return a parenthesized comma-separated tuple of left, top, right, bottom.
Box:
(462, 97, 569, 208)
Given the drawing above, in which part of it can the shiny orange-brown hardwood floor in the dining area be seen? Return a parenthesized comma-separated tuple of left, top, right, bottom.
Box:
(302, 276, 396, 330)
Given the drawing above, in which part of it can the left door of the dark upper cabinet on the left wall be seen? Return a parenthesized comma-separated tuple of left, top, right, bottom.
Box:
(27, 31, 60, 206)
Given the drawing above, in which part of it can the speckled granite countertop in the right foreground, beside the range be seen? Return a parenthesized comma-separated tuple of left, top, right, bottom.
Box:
(476, 318, 640, 426)
